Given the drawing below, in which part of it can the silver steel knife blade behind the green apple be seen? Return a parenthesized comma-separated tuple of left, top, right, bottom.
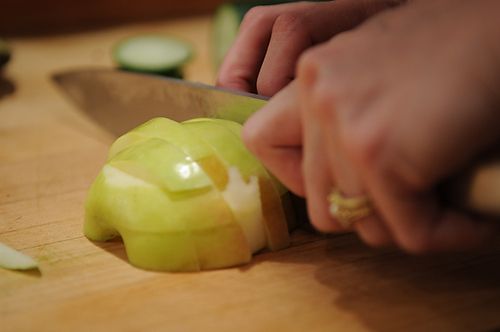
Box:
(52, 68, 266, 135)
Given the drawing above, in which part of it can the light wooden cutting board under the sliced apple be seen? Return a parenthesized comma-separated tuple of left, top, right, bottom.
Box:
(0, 17, 500, 332)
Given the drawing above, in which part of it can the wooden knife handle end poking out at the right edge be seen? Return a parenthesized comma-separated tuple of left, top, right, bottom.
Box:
(445, 157, 500, 220)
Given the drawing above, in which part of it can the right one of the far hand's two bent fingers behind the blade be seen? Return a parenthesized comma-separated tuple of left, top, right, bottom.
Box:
(257, 14, 313, 96)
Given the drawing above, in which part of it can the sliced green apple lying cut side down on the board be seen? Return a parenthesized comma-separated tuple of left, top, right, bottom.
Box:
(84, 118, 289, 271)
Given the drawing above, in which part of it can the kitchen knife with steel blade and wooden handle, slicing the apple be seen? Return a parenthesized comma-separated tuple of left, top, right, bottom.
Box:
(53, 68, 500, 220)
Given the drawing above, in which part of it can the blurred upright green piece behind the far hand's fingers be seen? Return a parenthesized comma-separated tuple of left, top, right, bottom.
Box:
(211, 0, 294, 70)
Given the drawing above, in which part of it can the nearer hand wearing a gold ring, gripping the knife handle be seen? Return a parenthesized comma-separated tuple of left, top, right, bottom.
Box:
(243, 0, 500, 252)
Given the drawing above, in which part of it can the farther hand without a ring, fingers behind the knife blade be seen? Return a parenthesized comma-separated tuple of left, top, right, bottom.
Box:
(217, 0, 401, 96)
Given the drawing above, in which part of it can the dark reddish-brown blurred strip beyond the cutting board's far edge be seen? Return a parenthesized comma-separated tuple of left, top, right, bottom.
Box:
(0, 0, 227, 36)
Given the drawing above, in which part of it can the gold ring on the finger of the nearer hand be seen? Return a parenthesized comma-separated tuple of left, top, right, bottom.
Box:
(328, 188, 373, 228)
